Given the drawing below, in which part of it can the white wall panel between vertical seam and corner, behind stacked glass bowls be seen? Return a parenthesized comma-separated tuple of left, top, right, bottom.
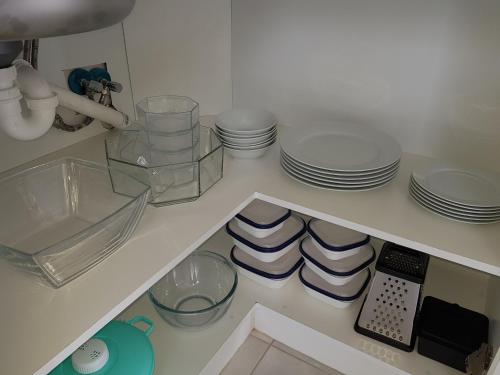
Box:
(124, 0, 231, 114)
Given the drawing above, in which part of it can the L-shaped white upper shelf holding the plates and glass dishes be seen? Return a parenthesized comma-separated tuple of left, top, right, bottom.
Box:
(0, 117, 500, 374)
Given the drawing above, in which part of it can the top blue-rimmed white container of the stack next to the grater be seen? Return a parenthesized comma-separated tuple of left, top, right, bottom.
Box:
(307, 219, 370, 260)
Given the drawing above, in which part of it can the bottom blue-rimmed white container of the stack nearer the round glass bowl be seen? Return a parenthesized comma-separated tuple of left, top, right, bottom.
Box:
(231, 246, 304, 288)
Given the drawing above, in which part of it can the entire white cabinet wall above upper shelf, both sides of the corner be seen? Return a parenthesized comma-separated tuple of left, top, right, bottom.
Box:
(0, 0, 500, 170)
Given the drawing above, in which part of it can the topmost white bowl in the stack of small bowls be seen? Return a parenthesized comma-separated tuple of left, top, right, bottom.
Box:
(216, 109, 276, 134)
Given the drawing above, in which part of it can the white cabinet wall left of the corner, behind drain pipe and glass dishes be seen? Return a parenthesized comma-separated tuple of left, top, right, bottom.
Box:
(0, 0, 231, 171)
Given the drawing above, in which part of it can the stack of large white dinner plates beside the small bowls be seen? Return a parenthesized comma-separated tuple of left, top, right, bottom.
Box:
(280, 122, 401, 190)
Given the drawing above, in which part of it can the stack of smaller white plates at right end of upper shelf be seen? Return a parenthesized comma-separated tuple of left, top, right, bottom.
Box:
(409, 163, 500, 224)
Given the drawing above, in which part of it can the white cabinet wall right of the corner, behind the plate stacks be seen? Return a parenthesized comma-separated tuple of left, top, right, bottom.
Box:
(232, 0, 500, 168)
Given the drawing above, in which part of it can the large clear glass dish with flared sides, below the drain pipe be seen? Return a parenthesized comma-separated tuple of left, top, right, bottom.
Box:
(0, 158, 150, 287)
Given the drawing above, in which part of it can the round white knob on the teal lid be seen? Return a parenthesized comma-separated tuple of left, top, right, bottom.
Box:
(71, 339, 109, 374)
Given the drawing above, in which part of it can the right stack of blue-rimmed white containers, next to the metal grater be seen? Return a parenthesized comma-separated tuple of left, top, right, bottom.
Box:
(299, 219, 376, 308)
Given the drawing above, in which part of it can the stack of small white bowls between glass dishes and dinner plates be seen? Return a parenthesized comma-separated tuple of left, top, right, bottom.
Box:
(215, 109, 277, 159)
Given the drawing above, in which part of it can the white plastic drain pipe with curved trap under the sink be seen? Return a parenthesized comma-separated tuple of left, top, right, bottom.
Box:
(0, 60, 130, 141)
